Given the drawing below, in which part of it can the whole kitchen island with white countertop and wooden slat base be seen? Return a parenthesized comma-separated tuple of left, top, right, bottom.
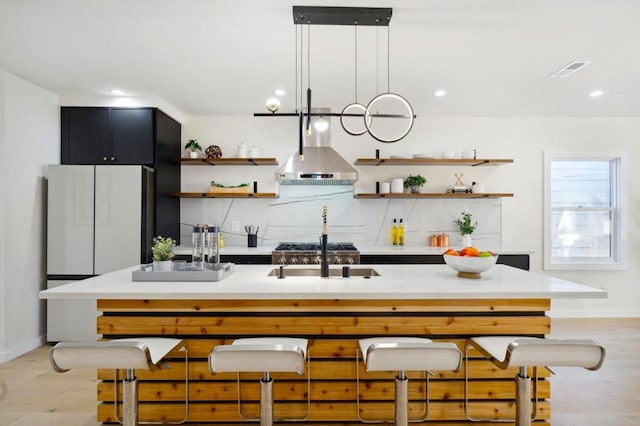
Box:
(41, 265, 606, 424)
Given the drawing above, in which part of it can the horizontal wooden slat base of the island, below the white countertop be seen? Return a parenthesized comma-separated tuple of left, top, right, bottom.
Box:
(97, 299, 551, 425)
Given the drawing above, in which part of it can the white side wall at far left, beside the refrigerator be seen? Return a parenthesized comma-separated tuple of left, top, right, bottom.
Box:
(0, 71, 60, 362)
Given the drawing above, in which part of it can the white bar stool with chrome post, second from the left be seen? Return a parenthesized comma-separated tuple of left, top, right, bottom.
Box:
(209, 337, 311, 426)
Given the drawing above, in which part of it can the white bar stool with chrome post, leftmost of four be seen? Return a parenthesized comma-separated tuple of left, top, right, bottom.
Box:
(49, 337, 189, 426)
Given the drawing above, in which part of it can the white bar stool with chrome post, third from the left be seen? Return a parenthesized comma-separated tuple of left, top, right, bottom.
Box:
(356, 337, 462, 426)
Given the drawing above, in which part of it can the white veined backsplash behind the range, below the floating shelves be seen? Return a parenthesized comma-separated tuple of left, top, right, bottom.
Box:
(181, 185, 502, 250)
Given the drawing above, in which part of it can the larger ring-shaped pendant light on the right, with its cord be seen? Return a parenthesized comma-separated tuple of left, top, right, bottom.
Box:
(364, 22, 415, 143)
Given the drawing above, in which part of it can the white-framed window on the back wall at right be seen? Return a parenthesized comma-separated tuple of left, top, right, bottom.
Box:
(544, 152, 624, 269)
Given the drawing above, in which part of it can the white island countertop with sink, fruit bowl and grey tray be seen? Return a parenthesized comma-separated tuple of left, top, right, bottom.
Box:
(40, 265, 607, 300)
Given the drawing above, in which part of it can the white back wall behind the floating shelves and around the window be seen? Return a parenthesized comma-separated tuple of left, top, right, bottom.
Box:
(182, 116, 640, 317)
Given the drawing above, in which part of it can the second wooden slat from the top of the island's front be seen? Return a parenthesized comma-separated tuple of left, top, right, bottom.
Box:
(98, 315, 551, 336)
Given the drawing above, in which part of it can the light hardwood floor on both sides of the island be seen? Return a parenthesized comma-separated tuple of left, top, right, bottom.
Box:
(0, 318, 640, 426)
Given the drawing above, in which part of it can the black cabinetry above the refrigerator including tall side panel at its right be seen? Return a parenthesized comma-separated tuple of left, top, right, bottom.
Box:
(61, 107, 182, 243)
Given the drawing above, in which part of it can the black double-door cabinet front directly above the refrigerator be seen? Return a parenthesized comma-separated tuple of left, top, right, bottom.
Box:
(61, 107, 154, 165)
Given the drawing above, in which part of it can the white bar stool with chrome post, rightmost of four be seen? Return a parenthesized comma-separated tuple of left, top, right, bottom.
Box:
(464, 336, 605, 426)
